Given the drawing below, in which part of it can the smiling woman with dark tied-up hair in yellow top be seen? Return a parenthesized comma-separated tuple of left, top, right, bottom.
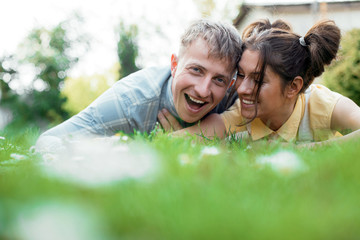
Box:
(159, 20, 360, 146)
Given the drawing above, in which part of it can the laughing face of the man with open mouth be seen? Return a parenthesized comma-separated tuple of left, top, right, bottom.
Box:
(171, 38, 232, 123)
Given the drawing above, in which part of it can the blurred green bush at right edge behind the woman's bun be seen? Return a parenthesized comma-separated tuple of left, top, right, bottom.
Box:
(323, 29, 360, 105)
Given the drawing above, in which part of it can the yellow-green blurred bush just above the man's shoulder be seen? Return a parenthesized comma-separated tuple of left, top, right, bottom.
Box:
(61, 64, 119, 115)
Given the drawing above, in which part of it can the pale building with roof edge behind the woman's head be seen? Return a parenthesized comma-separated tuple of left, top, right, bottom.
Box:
(233, 0, 360, 35)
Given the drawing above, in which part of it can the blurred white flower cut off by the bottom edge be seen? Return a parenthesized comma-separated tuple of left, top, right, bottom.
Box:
(11, 204, 104, 240)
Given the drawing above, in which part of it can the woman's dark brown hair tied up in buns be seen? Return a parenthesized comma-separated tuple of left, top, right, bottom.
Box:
(242, 20, 341, 121)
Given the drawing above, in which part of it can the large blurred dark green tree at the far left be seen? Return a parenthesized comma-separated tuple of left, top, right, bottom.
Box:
(15, 13, 88, 123)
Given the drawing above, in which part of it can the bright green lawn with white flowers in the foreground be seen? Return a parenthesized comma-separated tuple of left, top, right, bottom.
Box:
(0, 126, 360, 239)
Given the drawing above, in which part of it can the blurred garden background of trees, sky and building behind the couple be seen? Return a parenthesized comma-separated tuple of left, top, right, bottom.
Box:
(0, 0, 360, 131)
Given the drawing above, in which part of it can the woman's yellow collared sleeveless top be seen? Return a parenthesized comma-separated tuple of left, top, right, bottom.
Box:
(221, 84, 341, 142)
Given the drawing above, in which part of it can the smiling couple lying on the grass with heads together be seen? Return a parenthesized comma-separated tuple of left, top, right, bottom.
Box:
(37, 20, 360, 154)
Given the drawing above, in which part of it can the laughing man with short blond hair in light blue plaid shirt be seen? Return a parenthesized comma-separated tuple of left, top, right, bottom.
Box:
(37, 20, 241, 150)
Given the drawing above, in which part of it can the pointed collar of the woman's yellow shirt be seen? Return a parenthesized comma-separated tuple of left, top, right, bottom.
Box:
(250, 94, 305, 142)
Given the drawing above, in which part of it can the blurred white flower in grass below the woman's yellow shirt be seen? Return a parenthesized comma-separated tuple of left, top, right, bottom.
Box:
(256, 150, 307, 175)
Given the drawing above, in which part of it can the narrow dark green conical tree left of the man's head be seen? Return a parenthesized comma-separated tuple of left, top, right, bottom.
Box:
(117, 23, 140, 78)
